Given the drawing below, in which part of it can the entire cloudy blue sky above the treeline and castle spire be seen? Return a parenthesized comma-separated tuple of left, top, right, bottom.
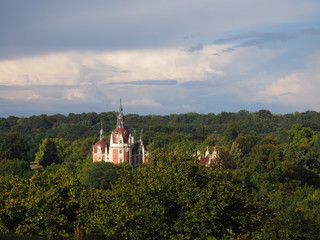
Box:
(0, 0, 320, 117)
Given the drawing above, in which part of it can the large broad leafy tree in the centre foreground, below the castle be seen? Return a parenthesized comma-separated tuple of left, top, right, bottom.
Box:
(96, 153, 260, 239)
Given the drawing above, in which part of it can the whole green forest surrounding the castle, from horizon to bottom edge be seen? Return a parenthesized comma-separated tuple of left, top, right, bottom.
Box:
(0, 110, 320, 240)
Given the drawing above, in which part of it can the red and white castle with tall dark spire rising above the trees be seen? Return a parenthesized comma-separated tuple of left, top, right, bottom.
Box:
(92, 100, 148, 167)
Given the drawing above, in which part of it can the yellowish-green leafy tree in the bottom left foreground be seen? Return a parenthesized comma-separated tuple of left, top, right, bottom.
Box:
(0, 169, 107, 239)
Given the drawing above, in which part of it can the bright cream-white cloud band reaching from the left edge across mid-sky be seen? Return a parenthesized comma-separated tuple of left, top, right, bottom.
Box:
(0, 46, 227, 86)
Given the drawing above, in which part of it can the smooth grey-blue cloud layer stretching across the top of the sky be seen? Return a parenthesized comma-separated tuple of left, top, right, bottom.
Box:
(0, 0, 320, 59)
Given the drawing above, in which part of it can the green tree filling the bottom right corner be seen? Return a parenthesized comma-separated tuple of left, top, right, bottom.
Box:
(255, 186, 320, 240)
